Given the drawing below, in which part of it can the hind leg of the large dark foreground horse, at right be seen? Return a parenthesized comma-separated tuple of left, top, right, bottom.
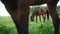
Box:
(47, 1, 59, 34)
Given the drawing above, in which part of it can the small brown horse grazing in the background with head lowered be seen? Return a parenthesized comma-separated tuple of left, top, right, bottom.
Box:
(31, 7, 49, 22)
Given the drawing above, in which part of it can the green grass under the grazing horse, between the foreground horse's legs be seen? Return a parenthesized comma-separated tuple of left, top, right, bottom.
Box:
(29, 17, 54, 34)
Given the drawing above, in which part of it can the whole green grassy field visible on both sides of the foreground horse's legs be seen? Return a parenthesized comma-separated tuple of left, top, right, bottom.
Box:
(0, 7, 60, 34)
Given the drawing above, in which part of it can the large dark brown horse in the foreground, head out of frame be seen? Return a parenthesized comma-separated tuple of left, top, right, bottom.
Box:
(0, 0, 59, 34)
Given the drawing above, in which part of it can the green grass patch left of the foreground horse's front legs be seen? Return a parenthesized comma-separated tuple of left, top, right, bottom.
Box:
(0, 16, 18, 34)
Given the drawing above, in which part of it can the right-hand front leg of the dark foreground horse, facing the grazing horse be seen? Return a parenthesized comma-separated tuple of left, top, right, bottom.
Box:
(17, 6, 29, 34)
